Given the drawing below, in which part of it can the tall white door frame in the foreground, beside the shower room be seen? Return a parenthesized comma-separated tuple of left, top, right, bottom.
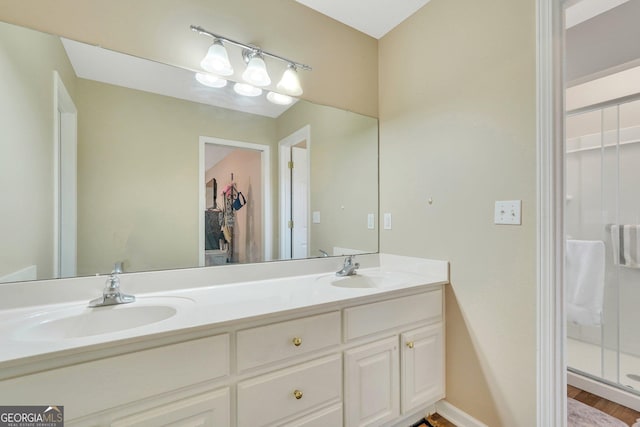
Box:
(536, 0, 567, 427)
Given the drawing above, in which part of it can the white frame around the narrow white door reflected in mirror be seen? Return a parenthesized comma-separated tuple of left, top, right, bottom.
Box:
(278, 125, 311, 259)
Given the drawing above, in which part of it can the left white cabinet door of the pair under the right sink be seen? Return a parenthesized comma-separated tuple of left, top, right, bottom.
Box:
(344, 336, 400, 427)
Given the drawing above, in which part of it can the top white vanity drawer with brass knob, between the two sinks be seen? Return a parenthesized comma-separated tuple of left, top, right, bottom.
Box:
(237, 311, 340, 371)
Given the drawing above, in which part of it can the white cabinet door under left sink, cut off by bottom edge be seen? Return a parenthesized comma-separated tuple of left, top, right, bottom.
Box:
(111, 388, 231, 427)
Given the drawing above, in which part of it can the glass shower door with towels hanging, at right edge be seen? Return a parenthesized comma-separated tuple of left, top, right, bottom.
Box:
(565, 100, 640, 391)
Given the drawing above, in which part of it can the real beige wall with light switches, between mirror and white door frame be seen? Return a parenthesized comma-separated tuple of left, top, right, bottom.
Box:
(379, 0, 536, 427)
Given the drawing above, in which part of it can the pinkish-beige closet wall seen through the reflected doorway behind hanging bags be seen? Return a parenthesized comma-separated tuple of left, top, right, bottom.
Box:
(205, 149, 264, 263)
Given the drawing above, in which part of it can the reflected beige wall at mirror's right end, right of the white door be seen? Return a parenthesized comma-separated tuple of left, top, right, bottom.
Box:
(277, 103, 378, 256)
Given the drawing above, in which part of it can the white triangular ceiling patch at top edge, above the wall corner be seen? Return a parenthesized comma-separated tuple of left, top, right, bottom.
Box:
(296, 0, 430, 39)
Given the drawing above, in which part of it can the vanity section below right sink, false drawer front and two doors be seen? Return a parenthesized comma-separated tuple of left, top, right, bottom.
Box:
(344, 289, 444, 427)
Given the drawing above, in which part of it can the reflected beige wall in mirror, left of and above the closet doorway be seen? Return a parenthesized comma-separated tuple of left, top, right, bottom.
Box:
(77, 79, 275, 275)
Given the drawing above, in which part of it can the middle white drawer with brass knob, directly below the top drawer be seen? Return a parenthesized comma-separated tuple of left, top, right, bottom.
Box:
(238, 354, 342, 427)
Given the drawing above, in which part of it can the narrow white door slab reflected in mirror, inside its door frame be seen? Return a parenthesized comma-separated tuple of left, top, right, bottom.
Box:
(291, 147, 309, 259)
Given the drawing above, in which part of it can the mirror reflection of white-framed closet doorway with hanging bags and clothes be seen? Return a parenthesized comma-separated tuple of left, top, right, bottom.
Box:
(199, 137, 270, 266)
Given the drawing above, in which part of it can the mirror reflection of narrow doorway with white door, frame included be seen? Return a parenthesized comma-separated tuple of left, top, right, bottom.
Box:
(279, 126, 310, 259)
